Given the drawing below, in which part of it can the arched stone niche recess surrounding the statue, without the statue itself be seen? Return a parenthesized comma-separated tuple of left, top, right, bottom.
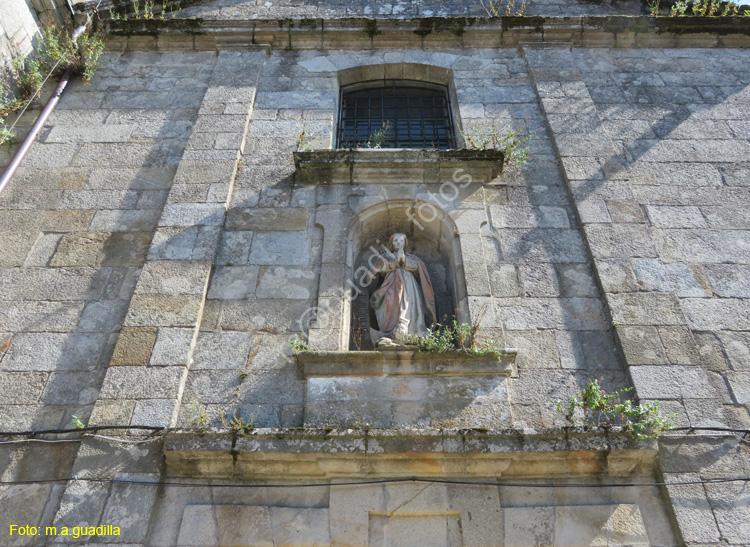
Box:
(342, 199, 469, 351)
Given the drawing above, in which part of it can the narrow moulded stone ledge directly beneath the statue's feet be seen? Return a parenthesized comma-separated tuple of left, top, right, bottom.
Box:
(297, 348, 518, 378)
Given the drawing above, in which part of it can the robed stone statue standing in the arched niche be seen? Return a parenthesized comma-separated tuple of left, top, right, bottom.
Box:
(370, 234, 437, 345)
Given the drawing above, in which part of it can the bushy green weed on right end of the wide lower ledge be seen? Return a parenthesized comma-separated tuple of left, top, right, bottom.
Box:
(556, 380, 674, 439)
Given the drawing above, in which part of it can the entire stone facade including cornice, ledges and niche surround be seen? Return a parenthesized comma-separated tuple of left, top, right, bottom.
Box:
(0, 0, 750, 547)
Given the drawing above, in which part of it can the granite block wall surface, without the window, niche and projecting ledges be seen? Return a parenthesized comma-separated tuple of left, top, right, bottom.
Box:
(0, 3, 750, 545)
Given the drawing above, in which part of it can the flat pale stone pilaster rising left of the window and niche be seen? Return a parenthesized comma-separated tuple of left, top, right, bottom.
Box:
(92, 52, 265, 427)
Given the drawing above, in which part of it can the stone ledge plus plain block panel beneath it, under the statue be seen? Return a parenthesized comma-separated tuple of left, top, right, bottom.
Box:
(297, 346, 516, 428)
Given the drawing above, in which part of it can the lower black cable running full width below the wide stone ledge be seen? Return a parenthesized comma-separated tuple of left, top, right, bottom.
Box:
(0, 477, 750, 488)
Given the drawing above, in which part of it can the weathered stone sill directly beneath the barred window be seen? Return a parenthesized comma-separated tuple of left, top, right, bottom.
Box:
(294, 148, 505, 184)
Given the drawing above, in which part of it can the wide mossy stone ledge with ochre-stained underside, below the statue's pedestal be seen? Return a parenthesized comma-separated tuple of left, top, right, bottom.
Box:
(164, 429, 657, 480)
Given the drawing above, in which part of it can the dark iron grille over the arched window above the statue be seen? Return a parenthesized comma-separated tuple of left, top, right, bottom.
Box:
(337, 80, 457, 150)
